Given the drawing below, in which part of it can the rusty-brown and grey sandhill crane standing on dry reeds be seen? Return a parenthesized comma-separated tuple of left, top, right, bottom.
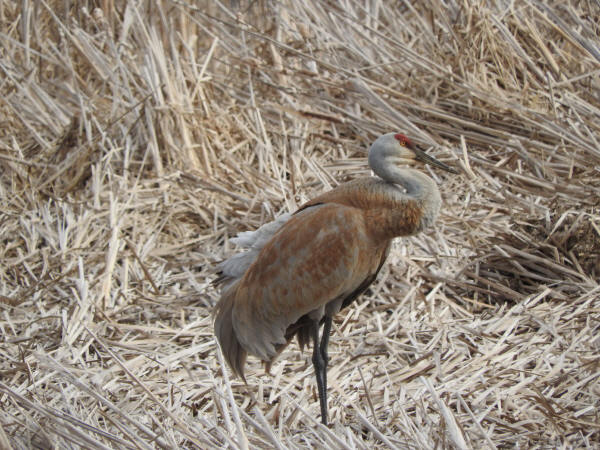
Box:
(214, 132, 458, 426)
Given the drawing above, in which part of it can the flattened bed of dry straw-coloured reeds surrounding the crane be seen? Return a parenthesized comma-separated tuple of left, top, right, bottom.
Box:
(0, 0, 600, 449)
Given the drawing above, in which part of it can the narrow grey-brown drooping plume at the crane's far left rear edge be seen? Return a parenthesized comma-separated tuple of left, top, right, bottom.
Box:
(214, 283, 247, 383)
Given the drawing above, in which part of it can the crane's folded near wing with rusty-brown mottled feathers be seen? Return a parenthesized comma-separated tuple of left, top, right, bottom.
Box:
(232, 204, 386, 361)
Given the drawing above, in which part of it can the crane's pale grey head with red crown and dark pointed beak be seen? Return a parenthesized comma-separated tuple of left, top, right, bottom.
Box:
(369, 133, 458, 173)
